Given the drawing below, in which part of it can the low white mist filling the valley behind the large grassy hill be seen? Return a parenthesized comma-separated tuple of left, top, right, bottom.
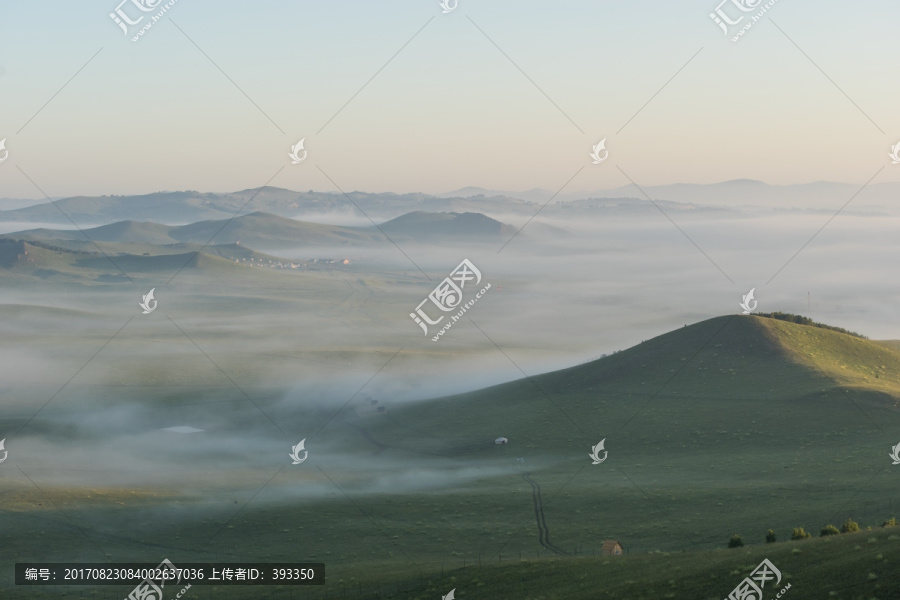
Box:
(0, 211, 900, 499)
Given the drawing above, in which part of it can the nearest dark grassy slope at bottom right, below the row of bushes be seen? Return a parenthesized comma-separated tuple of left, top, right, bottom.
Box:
(354, 528, 900, 600)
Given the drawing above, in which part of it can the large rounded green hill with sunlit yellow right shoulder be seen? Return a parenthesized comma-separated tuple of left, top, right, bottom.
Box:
(332, 315, 900, 568)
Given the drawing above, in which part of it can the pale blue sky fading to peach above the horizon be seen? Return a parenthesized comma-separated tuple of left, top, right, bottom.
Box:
(0, 0, 900, 198)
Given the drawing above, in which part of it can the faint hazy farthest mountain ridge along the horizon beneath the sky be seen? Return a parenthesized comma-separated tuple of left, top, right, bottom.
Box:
(0, 179, 900, 226)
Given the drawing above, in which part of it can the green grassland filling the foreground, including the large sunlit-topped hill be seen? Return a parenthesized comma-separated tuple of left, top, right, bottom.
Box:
(0, 312, 900, 600)
